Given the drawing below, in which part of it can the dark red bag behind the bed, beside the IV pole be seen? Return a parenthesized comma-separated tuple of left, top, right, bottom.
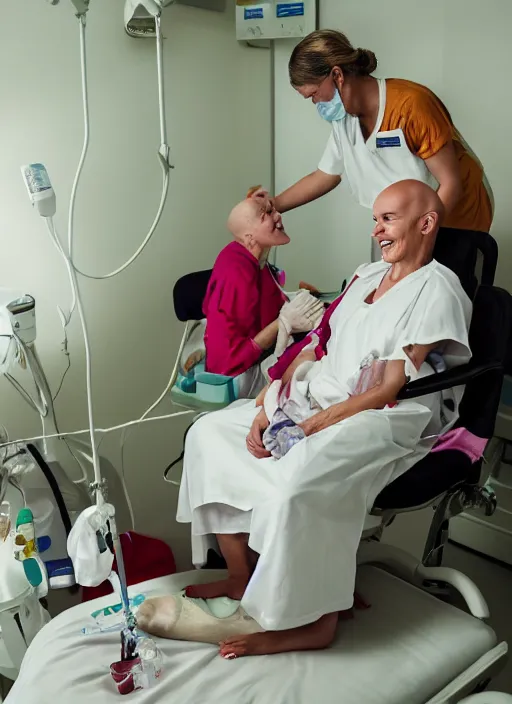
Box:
(82, 531, 176, 601)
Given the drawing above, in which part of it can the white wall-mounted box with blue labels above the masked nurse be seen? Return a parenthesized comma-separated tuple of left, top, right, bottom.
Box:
(236, 0, 317, 41)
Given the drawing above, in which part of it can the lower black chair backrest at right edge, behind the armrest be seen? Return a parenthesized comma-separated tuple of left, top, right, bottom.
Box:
(457, 286, 512, 438)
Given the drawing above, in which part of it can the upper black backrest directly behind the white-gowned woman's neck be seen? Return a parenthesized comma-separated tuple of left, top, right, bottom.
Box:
(434, 227, 498, 299)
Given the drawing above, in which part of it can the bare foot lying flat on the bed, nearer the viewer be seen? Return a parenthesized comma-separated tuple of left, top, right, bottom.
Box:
(219, 614, 338, 660)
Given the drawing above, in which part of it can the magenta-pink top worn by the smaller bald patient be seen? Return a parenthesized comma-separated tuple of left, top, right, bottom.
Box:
(203, 242, 286, 376)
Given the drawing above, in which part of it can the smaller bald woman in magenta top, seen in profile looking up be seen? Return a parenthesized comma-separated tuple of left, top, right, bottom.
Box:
(203, 198, 318, 398)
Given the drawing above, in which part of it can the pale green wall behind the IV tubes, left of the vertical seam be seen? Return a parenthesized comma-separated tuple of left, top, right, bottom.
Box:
(0, 0, 270, 566)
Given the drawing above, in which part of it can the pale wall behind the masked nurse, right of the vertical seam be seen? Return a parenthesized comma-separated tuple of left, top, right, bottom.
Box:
(275, 0, 512, 290)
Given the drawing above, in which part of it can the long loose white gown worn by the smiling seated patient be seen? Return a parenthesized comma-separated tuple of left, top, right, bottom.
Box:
(177, 261, 471, 630)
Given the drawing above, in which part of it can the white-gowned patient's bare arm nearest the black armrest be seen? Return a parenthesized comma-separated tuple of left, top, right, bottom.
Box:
(301, 343, 438, 435)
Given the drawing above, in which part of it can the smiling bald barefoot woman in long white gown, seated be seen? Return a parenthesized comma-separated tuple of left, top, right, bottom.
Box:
(173, 181, 471, 659)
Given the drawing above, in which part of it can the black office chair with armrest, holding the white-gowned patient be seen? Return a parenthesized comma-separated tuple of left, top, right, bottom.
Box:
(372, 286, 512, 567)
